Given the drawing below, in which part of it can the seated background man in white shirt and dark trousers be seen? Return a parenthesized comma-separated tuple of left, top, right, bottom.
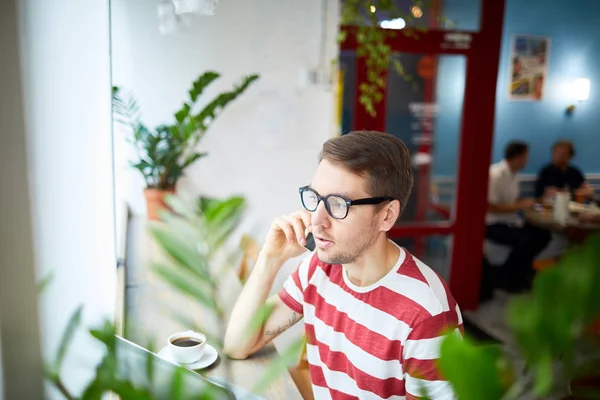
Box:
(485, 141, 551, 292)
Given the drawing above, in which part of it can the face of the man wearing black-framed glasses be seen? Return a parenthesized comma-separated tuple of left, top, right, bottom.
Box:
(310, 160, 385, 264)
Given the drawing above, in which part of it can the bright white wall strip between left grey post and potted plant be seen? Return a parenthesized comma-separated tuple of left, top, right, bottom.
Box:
(17, 0, 116, 392)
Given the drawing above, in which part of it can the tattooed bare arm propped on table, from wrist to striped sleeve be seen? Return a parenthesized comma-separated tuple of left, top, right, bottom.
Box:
(223, 253, 302, 359)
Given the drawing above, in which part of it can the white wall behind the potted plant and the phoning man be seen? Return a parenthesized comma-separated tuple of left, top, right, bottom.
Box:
(112, 0, 339, 244)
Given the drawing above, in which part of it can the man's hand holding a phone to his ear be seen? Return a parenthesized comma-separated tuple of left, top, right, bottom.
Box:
(262, 210, 312, 262)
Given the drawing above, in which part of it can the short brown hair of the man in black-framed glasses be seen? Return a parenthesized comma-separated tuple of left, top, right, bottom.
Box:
(319, 131, 413, 210)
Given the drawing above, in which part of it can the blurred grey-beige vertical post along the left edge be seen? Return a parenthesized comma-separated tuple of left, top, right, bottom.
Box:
(0, 0, 43, 400)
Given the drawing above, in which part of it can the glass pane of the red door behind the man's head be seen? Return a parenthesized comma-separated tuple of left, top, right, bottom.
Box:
(386, 54, 466, 223)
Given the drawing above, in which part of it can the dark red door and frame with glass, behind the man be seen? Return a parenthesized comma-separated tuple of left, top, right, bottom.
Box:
(341, 0, 504, 310)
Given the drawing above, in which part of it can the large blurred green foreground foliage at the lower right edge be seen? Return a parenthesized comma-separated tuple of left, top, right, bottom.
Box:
(508, 234, 600, 396)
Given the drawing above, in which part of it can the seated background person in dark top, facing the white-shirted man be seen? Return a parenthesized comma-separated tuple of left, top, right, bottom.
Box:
(535, 140, 594, 200)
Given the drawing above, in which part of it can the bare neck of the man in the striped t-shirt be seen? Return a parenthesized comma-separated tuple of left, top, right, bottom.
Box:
(344, 232, 400, 287)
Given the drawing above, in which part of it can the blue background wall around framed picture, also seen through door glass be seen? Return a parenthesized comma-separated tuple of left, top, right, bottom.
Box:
(434, 0, 600, 175)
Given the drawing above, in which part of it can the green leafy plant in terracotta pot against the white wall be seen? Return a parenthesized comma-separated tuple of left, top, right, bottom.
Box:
(113, 71, 258, 219)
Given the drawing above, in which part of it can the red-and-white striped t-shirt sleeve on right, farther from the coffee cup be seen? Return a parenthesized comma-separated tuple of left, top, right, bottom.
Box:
(402, 310, 462, 400)
